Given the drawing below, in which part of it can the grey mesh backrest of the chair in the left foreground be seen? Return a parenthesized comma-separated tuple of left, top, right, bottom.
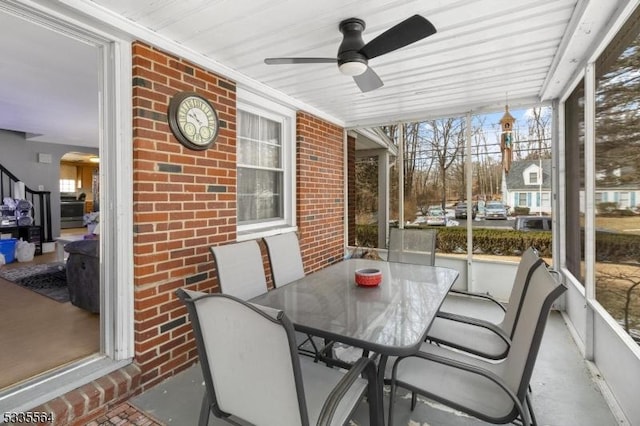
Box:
(176, 289, 308, 426)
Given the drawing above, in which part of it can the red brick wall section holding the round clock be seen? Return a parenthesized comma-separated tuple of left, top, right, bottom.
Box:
(133, 43, 236, 387)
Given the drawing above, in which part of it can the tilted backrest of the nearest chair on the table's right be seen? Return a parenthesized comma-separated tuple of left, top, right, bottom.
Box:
(503, 263, 567, 401)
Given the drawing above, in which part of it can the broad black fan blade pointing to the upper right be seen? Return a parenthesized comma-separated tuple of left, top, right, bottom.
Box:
(360, 15, 436, 59)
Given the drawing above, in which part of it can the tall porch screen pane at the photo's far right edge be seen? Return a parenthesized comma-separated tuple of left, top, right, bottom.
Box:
(595, 9, 640, 343)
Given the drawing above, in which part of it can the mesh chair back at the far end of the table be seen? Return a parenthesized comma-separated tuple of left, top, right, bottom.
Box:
(387, 228, 437, 266)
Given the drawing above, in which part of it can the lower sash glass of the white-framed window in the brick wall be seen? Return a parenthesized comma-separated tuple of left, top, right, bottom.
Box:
(238, 167, 283, 222)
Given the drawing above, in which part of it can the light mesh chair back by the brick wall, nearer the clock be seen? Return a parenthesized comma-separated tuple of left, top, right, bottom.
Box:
(211, 240, 267, 300)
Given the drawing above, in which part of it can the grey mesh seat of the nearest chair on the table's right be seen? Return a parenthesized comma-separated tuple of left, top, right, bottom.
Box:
(396, 343, 514, 419)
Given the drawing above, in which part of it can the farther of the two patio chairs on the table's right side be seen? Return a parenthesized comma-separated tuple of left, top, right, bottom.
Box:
(427, 248, 544, 360)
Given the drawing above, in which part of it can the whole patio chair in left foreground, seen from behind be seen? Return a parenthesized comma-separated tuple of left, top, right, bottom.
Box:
(176, 289, 379, 426)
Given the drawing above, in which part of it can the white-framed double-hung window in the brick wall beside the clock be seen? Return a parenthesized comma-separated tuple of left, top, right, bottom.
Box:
(237, 92, 295, 236)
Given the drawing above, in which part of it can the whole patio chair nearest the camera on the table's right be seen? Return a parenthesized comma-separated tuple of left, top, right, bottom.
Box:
(389, 264, 566, 426)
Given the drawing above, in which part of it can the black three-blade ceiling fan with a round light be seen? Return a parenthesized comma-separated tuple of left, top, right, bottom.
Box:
(264, 15, 436, 92)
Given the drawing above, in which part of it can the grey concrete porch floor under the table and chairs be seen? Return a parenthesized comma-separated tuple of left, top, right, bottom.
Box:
(129, 312, 622, 426)
